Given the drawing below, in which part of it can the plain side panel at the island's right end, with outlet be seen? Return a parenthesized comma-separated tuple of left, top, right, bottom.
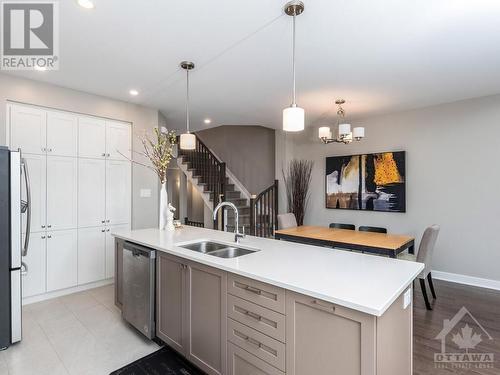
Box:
(377, 287, 413, 375)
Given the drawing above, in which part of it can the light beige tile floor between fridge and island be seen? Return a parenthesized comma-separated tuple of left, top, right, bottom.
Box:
(0, 285, 159, 375)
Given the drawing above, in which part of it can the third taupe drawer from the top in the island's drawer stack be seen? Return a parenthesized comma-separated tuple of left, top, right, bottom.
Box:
(227, 319, 285, 371)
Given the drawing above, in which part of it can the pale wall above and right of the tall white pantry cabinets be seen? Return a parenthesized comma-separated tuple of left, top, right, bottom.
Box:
(0, 73, 159, 228)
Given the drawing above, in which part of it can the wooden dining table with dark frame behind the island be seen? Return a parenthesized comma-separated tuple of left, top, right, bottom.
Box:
(275, 225, 415, 258)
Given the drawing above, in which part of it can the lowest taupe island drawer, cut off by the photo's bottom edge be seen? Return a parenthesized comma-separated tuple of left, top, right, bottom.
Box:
(227, 342, 284, 375)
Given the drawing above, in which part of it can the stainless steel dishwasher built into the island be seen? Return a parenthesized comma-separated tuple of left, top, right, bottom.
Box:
(122, 242, 156, 339)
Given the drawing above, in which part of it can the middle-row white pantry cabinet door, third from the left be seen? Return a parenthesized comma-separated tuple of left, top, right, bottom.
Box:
(78, 158, 106, 227)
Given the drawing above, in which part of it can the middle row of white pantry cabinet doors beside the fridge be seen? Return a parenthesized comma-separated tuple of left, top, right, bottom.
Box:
(22, 154, 131, 232)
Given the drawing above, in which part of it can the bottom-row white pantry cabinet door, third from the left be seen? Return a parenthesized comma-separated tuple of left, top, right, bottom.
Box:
(78, 227, 106, 285)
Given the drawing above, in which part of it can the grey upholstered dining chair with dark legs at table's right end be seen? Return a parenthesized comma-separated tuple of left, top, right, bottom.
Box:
(398, 225, 440, 310)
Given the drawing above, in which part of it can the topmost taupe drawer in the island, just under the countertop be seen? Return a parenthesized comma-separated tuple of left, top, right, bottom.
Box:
(227, 274, 285, 314)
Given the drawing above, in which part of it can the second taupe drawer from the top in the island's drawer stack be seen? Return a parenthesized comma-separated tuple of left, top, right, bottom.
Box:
(227, 295, 285, 342)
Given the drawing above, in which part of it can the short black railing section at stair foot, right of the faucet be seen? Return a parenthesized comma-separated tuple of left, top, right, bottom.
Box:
(250, 180, 278, 237)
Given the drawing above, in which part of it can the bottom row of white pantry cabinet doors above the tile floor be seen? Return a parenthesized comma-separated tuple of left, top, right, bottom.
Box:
(23, 224, 129, 297)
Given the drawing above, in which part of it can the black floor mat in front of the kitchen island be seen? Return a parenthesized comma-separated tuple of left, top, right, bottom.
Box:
(110, 346, 205, 375)
